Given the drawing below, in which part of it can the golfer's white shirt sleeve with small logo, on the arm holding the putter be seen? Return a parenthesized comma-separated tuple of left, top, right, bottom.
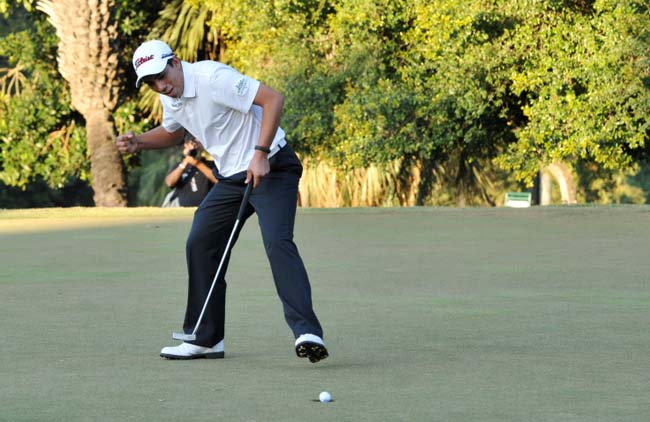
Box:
(210, 66, 260, 113)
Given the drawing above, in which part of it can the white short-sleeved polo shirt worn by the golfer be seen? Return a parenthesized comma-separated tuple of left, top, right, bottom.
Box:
(160, 61, 285, 177)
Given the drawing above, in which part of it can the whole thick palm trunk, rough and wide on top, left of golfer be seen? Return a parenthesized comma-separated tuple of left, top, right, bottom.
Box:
(37, 0, 126, 207)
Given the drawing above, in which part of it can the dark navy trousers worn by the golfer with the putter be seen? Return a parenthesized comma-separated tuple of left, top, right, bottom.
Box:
(183, 145, 323, 347)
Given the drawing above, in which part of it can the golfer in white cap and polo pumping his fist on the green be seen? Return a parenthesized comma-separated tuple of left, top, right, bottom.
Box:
(117, 40, 328, 362)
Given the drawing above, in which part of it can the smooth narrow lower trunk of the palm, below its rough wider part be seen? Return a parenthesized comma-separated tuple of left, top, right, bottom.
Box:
(84, 110, 127, 207)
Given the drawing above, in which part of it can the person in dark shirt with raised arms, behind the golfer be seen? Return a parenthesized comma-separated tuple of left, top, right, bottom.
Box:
(162, 137, 217, 208)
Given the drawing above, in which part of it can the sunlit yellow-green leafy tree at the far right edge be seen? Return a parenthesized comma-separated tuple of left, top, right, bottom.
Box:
(500, 0, 650, 185)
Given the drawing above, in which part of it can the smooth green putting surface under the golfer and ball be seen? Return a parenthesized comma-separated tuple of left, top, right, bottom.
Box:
(0, 206, 650, 422)
